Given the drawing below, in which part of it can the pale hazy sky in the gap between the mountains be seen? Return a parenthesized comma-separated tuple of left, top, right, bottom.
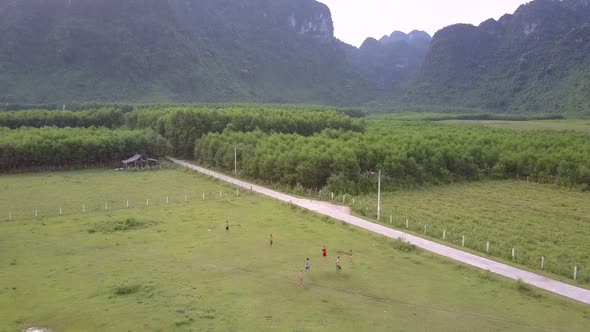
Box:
(318, 0, 531, 46)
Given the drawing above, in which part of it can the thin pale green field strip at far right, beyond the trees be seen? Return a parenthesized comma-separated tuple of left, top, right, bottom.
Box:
(442, 119, 590, 133)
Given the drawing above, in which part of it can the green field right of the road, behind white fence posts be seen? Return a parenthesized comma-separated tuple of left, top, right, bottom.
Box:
(354, 181, 590, 285)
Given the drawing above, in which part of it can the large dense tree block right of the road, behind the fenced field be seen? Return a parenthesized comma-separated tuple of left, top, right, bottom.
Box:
(195, 121, 590, 194)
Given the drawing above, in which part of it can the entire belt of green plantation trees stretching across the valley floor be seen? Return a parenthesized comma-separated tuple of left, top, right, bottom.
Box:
(0, 105, 590, 194)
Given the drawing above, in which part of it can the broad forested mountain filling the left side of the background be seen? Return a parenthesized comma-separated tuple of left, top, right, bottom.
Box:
(0, 0, 384, 104)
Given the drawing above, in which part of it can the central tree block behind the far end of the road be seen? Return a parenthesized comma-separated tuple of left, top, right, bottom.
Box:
(127, 107, 364, 156)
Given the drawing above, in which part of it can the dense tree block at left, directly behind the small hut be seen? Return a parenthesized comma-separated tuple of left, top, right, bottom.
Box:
(0, 127, 170, 170)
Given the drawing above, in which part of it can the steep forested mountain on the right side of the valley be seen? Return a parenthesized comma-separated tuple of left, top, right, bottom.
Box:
(402, 0, 590, 114)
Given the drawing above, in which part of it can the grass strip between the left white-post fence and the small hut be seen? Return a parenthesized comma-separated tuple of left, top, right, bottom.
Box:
(0, 169, 235, 221)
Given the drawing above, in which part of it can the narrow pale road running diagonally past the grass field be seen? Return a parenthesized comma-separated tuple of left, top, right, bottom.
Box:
(168, 158, 590, 304)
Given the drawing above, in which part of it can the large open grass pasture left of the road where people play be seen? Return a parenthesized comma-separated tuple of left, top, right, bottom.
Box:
(0, 171, 590, 332)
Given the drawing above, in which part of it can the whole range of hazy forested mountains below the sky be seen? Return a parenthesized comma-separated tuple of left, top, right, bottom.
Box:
(0, 0, 590, 112)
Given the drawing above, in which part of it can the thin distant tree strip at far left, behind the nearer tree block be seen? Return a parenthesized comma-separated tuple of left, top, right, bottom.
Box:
(0, 108, 125, 129)
